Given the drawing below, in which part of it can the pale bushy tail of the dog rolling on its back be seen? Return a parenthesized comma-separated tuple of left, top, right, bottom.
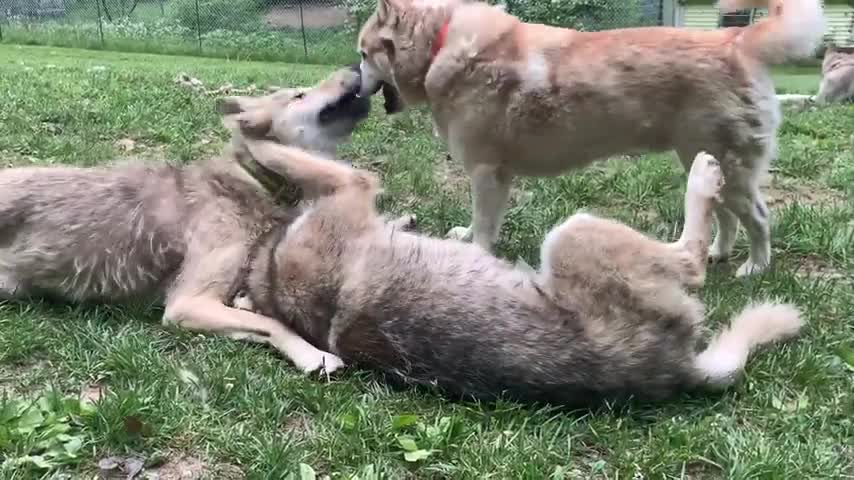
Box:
(694, 303, 803, 388)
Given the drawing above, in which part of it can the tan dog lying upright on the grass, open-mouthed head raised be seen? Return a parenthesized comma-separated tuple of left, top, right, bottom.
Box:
(0, 67, 370, 371)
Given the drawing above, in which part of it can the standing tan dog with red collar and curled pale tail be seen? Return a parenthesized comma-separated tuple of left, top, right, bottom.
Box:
(358, 0, 824, 275)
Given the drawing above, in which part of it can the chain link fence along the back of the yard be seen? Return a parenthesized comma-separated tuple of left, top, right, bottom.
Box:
(0, 0, 662, 64)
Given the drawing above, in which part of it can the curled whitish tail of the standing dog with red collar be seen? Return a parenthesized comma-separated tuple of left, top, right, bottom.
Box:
(718, 0, 825, 65)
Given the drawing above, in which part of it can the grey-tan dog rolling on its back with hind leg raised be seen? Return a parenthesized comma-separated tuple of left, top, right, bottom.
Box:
(238, 141, 801, 405)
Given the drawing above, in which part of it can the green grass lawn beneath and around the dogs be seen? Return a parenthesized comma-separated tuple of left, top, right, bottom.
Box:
(0, 45, 854, 480)
